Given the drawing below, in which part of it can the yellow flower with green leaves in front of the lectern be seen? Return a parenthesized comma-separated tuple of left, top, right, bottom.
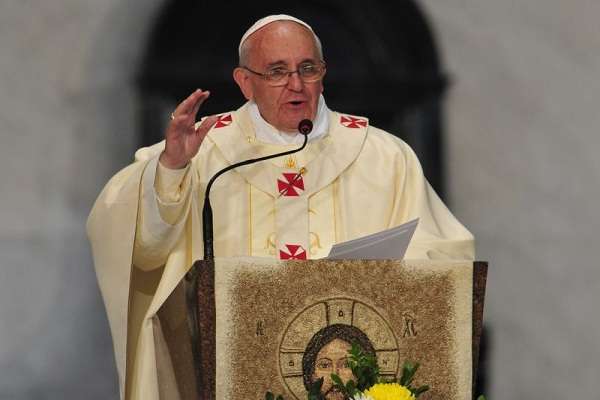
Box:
(265, 343, 485, 400)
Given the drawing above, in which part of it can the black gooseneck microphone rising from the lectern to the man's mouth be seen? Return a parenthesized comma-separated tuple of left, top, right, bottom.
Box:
(202, 119, 313, 260)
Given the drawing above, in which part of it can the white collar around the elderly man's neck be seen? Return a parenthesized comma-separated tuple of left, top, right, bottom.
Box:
(248, 95, 329, 145)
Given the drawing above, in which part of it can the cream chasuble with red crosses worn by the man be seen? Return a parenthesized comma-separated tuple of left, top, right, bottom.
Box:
(87, 101, 474, 400)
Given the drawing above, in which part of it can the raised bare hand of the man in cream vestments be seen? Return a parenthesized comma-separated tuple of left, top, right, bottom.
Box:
(159, 89, 217, 169)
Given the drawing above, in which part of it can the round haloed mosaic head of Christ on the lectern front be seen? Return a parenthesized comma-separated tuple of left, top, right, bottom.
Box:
(280, 298, 398, 400)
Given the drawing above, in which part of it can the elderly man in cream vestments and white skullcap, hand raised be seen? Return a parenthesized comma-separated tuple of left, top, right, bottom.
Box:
(88, 15, 474, 399)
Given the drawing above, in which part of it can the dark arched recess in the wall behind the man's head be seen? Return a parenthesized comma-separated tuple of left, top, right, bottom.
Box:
(138, 0, 448, 196)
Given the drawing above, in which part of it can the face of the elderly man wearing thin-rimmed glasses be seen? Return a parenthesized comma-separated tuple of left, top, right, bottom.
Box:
(234, 21, 323, 132)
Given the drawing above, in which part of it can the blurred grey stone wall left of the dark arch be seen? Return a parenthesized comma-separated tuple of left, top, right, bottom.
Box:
(0, 0, 161, 400)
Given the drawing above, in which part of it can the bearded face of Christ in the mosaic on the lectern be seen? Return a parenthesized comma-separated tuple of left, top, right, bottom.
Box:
(313, 339, 355, 400)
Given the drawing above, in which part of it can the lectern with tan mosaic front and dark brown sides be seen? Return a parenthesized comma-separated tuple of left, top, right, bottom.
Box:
(154, 258, 487, 400)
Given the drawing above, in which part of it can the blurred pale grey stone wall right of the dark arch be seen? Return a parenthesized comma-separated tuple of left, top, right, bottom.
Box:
(423, 0, 600, 399)
